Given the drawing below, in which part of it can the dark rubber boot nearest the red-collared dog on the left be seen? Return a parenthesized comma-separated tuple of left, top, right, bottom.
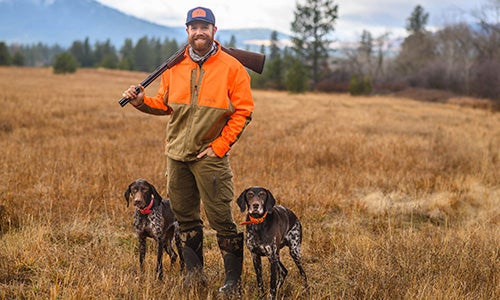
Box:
(180, 227, 207, 288)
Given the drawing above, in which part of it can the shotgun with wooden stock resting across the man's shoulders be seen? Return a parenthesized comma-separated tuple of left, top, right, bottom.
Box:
(118, 45, 266, 107)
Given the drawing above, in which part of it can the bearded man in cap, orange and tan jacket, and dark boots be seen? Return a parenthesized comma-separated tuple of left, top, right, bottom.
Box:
(123, 7, 254, 294)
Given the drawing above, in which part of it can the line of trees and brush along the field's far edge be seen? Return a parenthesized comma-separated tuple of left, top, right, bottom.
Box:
(0, 0, 500, 100)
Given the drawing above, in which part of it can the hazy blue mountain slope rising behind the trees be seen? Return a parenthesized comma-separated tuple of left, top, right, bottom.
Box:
(0, 0, 287, 48)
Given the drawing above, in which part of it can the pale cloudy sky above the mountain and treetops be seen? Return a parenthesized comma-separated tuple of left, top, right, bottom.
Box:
(97, 0, 488, 41)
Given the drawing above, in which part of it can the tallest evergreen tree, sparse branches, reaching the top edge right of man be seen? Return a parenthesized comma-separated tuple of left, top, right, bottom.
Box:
(292, 0, 338, 88)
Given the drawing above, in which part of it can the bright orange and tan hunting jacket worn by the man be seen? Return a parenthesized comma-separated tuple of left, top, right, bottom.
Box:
(138, 42, 254, 161)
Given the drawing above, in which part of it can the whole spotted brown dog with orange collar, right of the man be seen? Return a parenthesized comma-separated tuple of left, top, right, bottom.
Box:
(237, 187, 309, 299)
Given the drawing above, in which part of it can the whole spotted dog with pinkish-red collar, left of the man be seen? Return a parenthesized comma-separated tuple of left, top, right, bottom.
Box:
(124, 179, 184, 279)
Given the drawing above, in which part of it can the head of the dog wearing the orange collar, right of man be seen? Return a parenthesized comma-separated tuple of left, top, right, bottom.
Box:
(237, 186, 276, 218)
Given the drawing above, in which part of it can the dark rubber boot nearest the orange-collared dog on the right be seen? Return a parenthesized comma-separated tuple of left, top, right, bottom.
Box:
(217, 232, 243, 298)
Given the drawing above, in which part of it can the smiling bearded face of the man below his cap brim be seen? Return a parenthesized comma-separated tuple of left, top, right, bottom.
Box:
(186, 21, 217, 55)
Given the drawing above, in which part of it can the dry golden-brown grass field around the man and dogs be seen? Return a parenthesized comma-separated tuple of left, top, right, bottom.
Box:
(0, 67, 500, 299)
